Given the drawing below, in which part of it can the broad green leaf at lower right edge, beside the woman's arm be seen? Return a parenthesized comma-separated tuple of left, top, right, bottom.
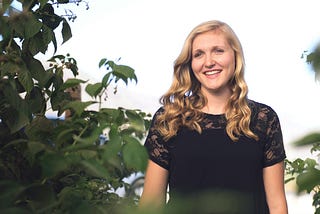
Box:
(297, 169, 320, 193)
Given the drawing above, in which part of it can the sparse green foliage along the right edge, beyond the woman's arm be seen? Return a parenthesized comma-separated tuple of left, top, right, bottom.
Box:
(286, 43, 320, 214)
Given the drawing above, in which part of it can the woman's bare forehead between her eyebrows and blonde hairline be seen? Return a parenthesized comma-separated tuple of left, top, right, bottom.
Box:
(192, 30, 230, 50)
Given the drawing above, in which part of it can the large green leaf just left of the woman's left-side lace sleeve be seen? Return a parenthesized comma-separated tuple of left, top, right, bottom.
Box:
(122, 136, 148, 172)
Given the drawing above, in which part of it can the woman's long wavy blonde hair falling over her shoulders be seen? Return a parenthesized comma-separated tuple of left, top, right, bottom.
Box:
(155, 20, 258, 141)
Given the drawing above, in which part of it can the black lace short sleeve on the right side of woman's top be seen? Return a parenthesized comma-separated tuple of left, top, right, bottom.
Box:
(257, 103, 286, 167)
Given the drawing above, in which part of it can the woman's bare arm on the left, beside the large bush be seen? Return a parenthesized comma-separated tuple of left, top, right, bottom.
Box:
(139, 160, 169, 209)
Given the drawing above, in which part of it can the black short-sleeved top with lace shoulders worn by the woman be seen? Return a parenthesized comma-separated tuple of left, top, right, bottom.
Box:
(145, 100, 286, 214)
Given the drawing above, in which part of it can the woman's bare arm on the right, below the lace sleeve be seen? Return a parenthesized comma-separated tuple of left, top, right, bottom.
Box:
(263, 161, 288, 214)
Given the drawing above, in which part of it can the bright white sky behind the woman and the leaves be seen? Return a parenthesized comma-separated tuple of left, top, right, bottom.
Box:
(43, 0, 320, 211)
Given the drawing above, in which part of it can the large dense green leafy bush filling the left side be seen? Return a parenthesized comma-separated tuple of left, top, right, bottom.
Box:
(0, 0, 150, 213)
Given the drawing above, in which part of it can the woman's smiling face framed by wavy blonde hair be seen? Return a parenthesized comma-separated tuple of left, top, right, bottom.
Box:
(191, 30, 235, 95)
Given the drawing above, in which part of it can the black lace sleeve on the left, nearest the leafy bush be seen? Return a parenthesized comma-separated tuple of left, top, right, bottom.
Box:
(144, 108, 170, 170)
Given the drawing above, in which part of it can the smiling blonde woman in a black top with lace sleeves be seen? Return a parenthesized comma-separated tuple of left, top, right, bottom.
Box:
(140, 21, 287, 214)
